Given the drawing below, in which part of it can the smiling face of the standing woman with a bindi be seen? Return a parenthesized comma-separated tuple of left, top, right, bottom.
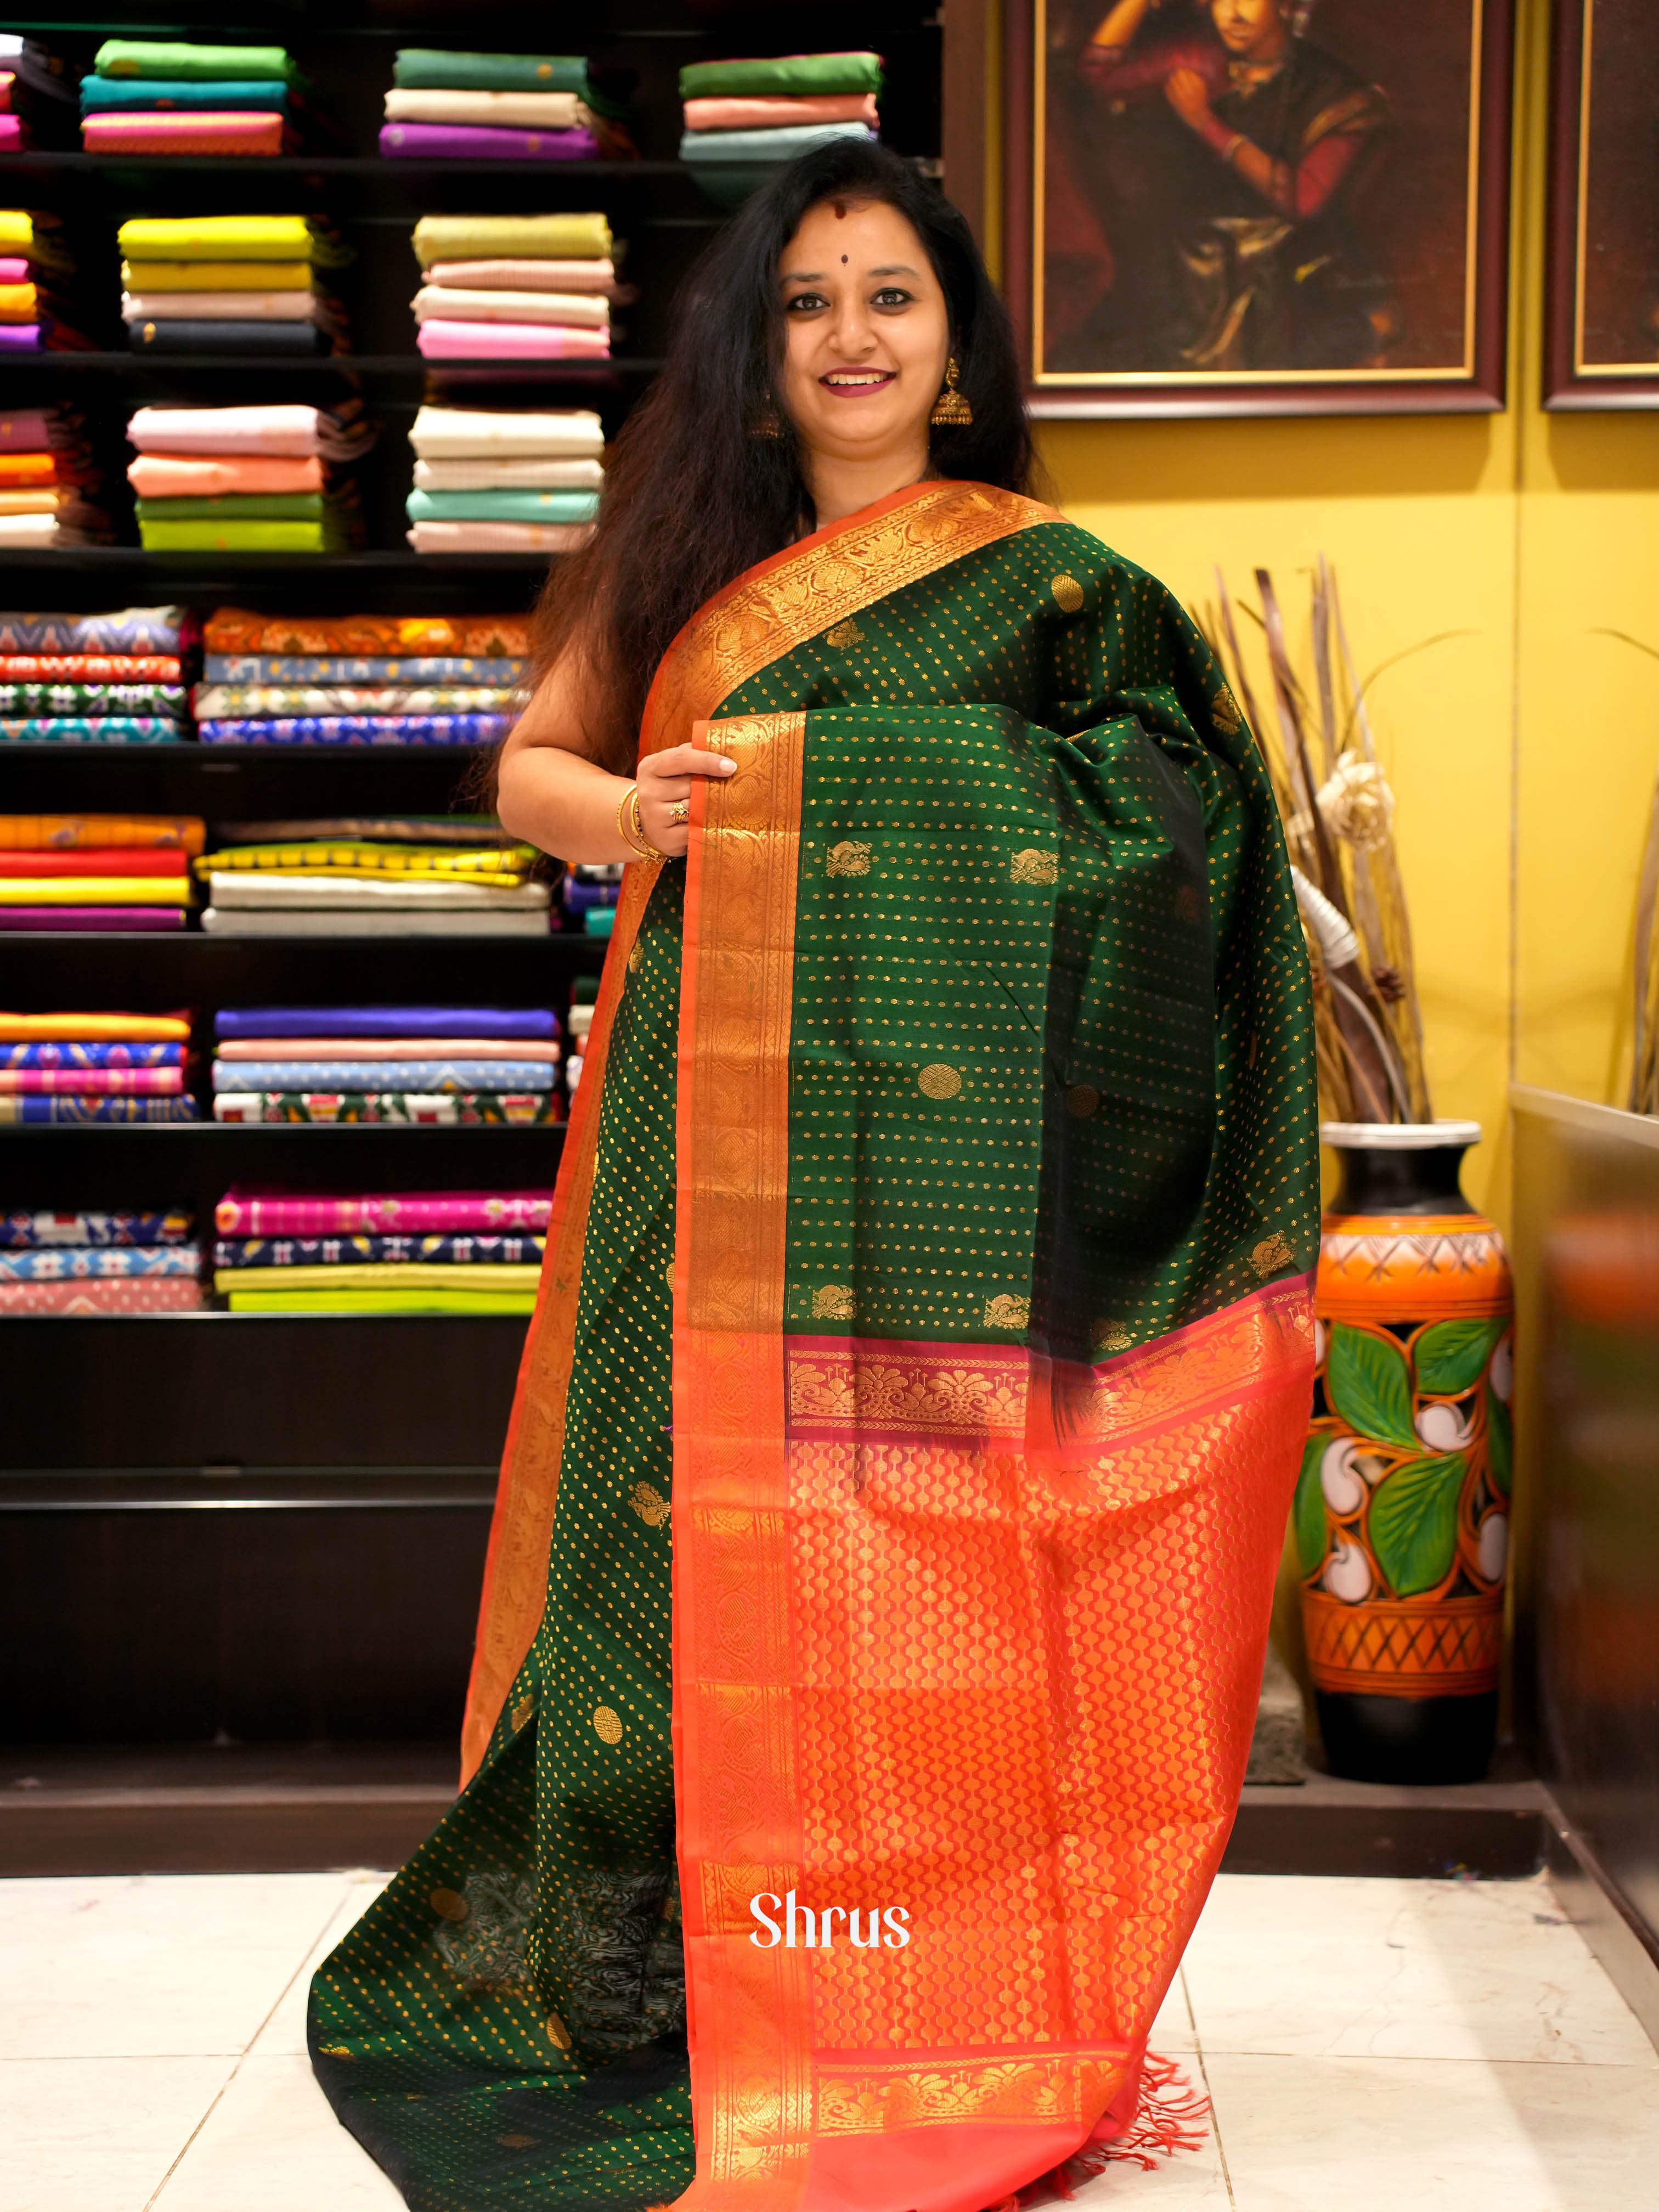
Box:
(778, 199, 951, 460)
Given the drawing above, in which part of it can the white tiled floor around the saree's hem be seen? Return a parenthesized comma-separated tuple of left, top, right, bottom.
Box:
(0, 1874, 1659, 2212)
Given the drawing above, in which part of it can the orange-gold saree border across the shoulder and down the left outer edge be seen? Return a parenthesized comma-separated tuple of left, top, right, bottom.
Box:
(460, 482, 1064, 1785)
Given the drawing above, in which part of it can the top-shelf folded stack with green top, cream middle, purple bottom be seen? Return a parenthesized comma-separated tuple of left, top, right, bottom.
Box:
(381, 47, 635, 161)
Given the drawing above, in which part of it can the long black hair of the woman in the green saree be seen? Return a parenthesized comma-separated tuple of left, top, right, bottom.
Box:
(538, 139, 1035, 774)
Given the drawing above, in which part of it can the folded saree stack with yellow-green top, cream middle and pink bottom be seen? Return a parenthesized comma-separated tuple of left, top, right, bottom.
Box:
(414, 215, 617, 369)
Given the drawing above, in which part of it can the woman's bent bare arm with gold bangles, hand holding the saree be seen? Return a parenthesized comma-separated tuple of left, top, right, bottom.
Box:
(495, 650, 735, 865)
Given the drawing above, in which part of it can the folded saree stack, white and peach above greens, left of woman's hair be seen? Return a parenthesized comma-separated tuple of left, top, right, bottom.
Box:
(126, 398, 374, 553)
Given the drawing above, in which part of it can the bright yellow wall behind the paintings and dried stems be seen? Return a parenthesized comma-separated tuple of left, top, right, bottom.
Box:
(1026, 0, 1659, 1219)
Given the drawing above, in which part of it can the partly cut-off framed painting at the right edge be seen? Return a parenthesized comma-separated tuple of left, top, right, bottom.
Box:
(1544, 0, 1659, 407)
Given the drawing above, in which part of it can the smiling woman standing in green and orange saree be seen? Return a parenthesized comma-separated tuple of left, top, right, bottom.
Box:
(312, 144, 1316, 2212)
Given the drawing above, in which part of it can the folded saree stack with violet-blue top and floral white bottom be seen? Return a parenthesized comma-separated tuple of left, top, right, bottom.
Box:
(212, 1007, 564, 1132)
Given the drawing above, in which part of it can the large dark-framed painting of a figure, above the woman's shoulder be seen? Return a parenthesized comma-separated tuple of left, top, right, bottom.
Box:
(1002, 0, 1522, 416)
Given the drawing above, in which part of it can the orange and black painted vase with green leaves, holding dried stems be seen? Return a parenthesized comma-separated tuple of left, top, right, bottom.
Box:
(1294, 1121, 1513, 1783)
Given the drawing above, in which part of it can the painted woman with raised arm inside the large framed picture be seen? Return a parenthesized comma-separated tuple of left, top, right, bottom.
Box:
(1066, 0, 1398, 374)
